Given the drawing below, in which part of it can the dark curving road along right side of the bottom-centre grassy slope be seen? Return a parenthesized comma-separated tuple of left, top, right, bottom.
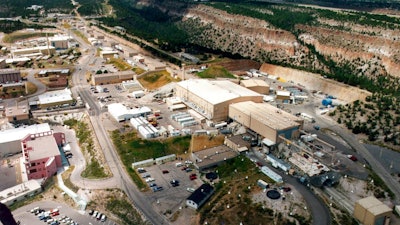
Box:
(250, 150, 331, 225)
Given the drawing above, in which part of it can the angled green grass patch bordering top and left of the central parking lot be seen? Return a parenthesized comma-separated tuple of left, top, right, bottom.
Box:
(111, 130, 190, 190)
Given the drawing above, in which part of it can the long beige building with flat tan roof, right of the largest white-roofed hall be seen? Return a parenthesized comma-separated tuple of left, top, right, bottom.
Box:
(229, 101, 303, 146)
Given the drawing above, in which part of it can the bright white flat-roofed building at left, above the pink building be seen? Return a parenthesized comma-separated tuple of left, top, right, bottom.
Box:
(33, 88, 73, 109)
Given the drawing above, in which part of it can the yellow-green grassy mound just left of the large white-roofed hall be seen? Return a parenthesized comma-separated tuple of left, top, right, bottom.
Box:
(138, 70, 179, 90)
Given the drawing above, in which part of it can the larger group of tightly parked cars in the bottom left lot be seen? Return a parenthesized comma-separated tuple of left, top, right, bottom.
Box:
(31, 207, 78, 225)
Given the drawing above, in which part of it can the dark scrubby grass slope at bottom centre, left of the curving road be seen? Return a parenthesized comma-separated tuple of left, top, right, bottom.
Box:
(199, 155, 282, 225)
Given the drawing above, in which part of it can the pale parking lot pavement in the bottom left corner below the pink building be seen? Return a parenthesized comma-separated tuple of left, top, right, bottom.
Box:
(13, 201, 115, 225)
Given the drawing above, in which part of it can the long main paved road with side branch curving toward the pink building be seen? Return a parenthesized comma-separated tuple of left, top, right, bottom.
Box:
(71, 23, 168, 224)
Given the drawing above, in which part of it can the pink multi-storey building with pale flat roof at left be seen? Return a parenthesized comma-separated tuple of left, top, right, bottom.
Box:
(21, 131, 65, 180)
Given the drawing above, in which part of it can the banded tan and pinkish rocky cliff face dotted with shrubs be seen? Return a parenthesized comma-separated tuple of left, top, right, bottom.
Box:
(147, 1, 400, 82)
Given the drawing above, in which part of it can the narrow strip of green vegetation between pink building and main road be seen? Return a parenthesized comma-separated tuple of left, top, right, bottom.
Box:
(64, 119, 108, 179)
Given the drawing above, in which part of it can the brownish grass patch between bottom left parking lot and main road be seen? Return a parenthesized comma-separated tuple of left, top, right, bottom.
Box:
(106, 194, 147, 225)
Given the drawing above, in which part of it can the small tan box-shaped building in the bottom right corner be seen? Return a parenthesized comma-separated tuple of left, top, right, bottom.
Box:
(353, 196, 392, 225)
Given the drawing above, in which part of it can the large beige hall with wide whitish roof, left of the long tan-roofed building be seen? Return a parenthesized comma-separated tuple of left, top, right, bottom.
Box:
(176, 79, 263, 122)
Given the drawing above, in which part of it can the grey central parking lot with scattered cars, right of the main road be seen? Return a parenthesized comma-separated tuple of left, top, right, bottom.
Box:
(139, 161, 203, 212)
